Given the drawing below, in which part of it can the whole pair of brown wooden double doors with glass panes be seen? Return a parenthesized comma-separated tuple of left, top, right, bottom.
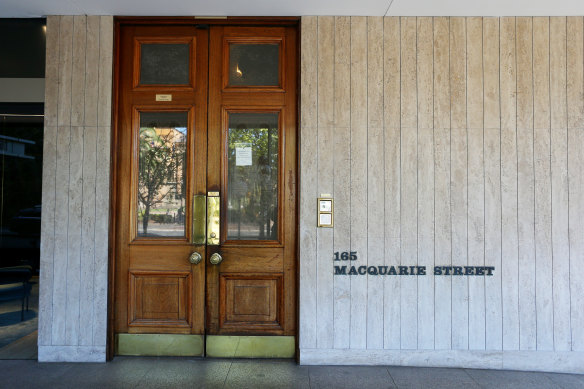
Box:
(113, 24, 297, 354)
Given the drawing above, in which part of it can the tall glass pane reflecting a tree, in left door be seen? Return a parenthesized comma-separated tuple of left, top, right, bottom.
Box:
(136, 112, 188, 237)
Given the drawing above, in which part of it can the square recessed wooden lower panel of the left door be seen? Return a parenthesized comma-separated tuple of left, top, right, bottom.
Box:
(128, 271, 192, 328)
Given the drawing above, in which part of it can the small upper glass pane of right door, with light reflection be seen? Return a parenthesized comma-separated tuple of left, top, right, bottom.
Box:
(229, 43, 280, 86)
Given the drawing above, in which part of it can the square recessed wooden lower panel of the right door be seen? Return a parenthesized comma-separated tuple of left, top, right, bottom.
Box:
(219, 273, 284, 332)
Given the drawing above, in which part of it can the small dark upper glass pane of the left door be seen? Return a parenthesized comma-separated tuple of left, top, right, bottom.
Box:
(140, 43, 190, 85)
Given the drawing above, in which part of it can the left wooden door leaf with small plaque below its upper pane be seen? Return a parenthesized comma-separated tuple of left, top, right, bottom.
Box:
(113, 25, 208, 346)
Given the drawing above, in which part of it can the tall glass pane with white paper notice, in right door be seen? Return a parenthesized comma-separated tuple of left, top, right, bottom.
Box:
(227, 112, 279, 240)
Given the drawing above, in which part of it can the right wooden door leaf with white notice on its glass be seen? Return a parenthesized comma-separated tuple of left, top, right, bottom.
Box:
(206, 26, 297, 335)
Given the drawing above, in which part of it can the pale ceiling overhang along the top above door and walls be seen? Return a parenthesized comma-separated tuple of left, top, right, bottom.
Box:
(0, 0, 584, 18)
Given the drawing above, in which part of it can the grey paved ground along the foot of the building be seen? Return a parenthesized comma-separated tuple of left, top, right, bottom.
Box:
(0, 357, 584, 389)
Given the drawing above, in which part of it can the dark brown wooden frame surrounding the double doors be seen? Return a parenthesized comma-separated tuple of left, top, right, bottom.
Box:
(106, 16, 301, 361)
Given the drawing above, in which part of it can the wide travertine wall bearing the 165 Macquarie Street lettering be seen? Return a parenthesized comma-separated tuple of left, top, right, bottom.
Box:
(299, 17, 584, 372)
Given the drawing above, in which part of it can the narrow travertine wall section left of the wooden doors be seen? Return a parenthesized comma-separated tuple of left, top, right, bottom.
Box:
(38, 16, 113, 361)
